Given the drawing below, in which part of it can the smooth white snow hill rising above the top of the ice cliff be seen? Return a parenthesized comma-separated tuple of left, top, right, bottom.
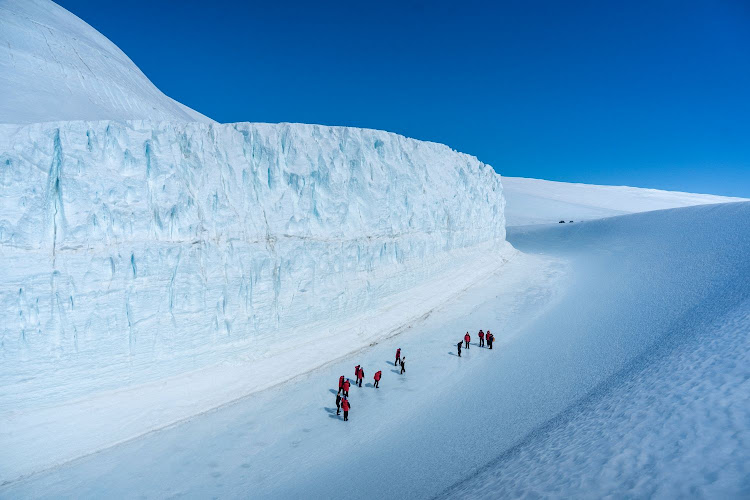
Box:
(0, 0, 212, 123)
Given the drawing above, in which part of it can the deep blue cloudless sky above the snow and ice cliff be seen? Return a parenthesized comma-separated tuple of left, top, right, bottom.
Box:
(59, 0, 750, 197)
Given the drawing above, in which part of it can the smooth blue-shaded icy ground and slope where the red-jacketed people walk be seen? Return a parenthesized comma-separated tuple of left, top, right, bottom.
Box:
(0, 203, 750, 498)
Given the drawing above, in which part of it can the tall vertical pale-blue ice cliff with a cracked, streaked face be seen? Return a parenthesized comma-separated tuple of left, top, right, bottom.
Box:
(0, 121, 505, 405)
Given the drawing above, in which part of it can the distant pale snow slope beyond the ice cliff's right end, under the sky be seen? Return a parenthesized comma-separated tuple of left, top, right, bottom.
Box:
(503, 177, 748, 226)
